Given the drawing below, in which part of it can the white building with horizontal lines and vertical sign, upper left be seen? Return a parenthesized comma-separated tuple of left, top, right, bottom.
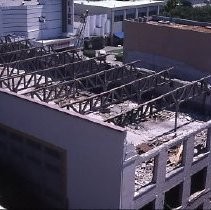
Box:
(0, 0, 73, 39)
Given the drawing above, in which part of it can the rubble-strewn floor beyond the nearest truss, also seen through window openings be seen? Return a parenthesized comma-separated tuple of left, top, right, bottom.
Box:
(132, 111, 207, 192)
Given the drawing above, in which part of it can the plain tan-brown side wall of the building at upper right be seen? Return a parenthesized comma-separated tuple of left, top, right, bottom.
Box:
(123, 21, 211, 72)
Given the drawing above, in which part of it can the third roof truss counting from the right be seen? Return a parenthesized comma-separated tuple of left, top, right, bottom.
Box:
(27, 61, 147, 102)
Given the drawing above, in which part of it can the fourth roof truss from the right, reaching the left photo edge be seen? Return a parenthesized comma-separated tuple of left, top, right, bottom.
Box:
(0, 55, 107, 92)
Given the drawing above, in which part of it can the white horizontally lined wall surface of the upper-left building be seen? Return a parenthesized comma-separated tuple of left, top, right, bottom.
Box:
(0, 0, 73, 39)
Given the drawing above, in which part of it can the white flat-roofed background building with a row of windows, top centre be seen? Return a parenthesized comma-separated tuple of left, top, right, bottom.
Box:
(74, 0, 164, 35)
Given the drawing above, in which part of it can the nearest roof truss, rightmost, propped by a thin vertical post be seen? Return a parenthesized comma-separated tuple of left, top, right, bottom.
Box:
(105, 76, 211, 127)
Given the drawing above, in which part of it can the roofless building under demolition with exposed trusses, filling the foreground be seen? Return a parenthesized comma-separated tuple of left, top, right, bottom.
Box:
(0, 36, 211, 209)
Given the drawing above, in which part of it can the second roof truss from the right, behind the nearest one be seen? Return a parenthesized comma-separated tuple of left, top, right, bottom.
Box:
(61, 69, 171, 114)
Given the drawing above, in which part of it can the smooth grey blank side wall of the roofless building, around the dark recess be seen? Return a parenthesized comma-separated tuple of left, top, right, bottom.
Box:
(0, 91, 126, 209)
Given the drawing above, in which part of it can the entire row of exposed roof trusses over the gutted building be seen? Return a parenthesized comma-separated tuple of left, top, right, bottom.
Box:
(0, 36, 211, 130)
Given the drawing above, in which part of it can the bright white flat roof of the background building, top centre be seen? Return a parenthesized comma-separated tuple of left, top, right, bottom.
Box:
(74, 0, 163, 8)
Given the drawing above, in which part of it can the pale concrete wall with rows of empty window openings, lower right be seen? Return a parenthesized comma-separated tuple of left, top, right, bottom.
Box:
(121, 121, 211, 209)
